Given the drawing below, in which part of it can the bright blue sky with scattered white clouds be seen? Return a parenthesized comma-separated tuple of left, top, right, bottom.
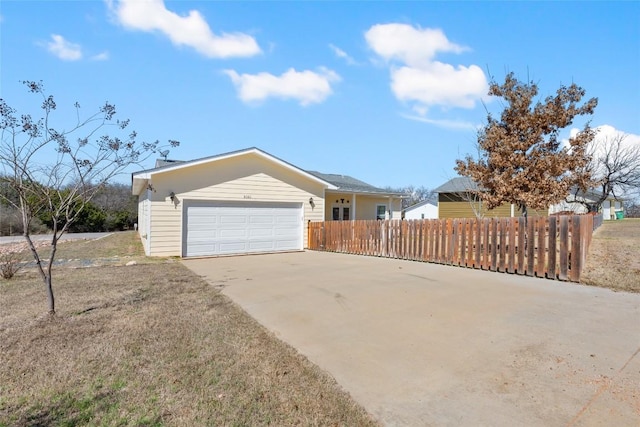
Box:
(0, 0, 640, 188)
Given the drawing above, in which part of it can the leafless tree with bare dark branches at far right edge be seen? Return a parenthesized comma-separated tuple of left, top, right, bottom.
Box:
(573, 133, 640, 212)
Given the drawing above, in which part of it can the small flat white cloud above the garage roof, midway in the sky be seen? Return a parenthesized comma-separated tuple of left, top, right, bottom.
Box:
(224, 68, 340, 106)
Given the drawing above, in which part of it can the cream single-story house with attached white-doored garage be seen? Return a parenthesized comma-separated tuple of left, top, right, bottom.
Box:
(131, 147, 402, 257)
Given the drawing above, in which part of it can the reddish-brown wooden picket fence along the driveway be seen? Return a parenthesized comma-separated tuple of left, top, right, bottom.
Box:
(309, 215, 597, 282)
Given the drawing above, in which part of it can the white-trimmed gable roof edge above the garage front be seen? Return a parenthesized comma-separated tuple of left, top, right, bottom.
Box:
(131, 147, 337, 194)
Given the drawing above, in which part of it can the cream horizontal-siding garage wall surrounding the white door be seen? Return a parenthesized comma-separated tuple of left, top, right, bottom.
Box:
(145, 153, 324, 256)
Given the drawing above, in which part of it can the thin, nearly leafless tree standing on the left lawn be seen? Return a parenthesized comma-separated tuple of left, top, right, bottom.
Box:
(0, 81, 179, 314)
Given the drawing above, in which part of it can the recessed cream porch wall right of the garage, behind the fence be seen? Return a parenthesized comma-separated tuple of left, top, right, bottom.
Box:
(324, 191, 402, 221)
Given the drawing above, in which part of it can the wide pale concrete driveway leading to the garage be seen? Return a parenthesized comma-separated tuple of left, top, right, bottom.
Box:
(184, 252, 640, 426)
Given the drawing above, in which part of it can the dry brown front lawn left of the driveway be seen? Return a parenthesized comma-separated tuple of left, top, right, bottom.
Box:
(0, 233, 375, 426)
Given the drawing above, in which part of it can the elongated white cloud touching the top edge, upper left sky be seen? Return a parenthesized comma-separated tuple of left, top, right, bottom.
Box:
(107, 0, 261, 58)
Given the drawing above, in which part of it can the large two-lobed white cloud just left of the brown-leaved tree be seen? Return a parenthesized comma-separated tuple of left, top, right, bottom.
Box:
(365, 24, 489, 116)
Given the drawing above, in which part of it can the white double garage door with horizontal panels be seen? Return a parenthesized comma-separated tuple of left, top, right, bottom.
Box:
(183, 202, 303, 256)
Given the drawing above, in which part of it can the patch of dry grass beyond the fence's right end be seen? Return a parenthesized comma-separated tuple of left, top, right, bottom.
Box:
(581, 218, 640, 292)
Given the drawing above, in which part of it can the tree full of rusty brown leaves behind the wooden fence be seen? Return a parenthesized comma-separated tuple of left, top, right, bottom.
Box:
(455, 73, 597, 216)
